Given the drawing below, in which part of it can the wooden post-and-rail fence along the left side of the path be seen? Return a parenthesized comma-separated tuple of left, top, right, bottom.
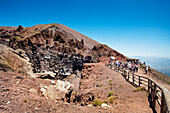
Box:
(106, 64, 170, 113)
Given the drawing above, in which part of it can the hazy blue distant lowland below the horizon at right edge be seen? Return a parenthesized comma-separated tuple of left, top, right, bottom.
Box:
(134, 56, 170, 76)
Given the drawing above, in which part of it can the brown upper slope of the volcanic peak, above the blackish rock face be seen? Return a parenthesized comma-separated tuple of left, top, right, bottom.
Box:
(0, 24, 127, 60)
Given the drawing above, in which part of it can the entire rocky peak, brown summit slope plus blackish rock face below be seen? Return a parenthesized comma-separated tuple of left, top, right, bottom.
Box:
(0, 24, 129, 78)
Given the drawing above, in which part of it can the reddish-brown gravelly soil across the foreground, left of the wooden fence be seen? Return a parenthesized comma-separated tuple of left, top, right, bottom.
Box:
(0, 63, 152, 113)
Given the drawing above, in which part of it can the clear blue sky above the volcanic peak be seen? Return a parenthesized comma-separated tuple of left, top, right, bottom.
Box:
(0, 0, 170, 58)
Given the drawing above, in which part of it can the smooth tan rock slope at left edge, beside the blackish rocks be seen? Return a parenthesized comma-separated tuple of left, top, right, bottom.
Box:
(0, 44, 35, 77)
